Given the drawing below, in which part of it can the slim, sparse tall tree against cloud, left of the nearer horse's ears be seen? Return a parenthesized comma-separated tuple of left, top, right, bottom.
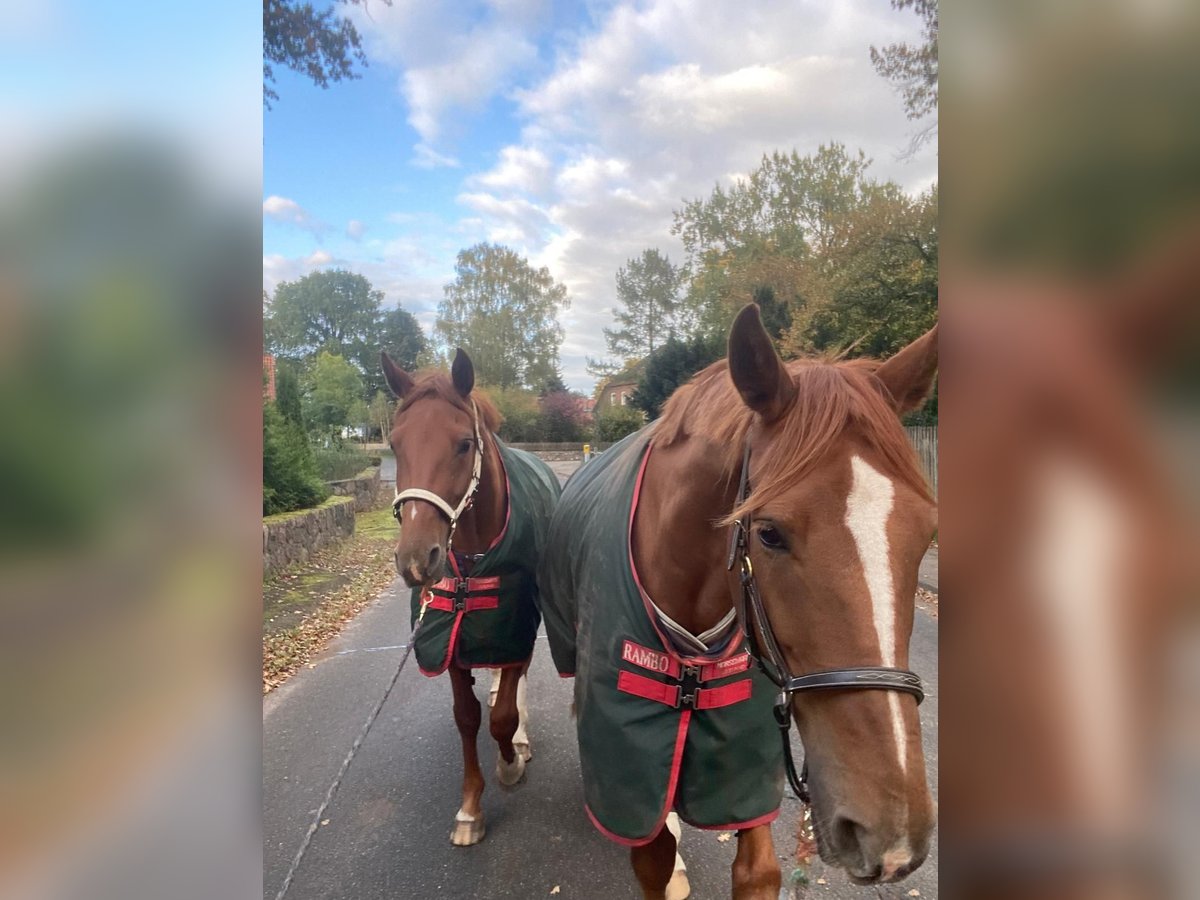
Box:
(604, 250, 680, 359)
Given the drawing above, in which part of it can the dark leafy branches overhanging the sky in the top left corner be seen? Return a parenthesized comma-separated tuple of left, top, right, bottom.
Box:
(263, 0, 391, 109)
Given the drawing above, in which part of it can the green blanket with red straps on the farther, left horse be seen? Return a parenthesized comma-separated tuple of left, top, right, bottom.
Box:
(410, 439, 562, 677)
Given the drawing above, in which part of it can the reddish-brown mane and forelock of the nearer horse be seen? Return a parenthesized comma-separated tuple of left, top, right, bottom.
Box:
(654, 359, 932, 522)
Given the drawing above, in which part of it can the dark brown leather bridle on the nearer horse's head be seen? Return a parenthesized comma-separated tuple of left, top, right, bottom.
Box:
(726, 437, 925, 803)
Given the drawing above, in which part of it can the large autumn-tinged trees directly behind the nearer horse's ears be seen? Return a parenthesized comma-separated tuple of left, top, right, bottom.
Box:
(672, 144, 937, 357)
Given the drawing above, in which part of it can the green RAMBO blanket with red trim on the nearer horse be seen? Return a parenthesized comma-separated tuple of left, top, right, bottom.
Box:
(539, 426, 784, 846)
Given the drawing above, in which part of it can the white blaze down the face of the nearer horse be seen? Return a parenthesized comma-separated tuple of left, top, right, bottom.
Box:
(846, 456, 908, 772)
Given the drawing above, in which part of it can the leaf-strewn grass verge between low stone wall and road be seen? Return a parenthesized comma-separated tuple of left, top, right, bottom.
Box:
(263, 506, 396, 694)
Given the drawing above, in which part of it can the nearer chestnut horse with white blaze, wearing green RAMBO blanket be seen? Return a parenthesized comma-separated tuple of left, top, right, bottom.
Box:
(539, 305, 937, 900)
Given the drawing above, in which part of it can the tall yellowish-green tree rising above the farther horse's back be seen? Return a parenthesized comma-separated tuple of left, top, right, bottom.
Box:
(437, 244, 569, 389)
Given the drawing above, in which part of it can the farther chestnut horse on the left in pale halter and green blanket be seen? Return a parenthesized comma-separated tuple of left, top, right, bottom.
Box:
(382, 350, 559, 846)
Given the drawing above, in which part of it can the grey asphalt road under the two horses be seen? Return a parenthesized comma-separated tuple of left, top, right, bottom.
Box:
(263, 460, 938, 900)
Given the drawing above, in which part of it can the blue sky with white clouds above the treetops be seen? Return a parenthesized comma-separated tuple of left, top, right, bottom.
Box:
(263, 0, 937, 390)
